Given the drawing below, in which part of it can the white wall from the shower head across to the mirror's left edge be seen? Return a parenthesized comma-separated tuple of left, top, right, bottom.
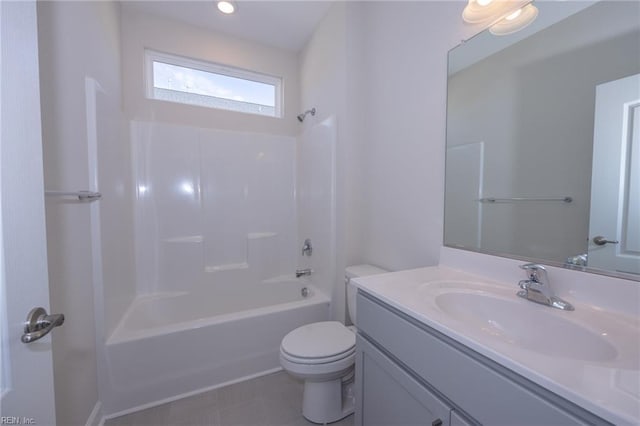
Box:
(299, 2, 474, 319)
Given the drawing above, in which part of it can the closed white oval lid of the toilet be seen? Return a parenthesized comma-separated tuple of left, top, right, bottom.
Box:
(281, 321, 356, 358)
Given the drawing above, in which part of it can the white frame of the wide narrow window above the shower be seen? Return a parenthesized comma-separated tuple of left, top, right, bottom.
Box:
(144, 49, 284, 118)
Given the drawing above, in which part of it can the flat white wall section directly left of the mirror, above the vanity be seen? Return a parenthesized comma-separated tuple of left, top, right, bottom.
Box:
(358, 2, 476, 270)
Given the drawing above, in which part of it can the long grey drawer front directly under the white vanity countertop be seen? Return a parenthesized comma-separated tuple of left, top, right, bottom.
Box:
(357, 291, 608, 426)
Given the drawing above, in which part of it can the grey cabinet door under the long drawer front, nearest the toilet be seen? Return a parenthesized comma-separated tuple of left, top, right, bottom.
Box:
(356, 336, 451, 426)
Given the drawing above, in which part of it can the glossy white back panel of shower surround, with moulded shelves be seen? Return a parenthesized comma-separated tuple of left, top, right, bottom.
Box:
(131, 122, 297, 294)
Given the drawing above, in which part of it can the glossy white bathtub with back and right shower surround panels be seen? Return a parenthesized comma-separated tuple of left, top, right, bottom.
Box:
(103, 119, 335, 417)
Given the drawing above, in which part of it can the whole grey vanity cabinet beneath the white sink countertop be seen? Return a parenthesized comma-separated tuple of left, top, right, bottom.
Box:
(356, 290, 610, 426)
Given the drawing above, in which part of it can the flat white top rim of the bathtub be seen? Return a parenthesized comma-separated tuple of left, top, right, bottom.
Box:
(106, 284, 331, 345)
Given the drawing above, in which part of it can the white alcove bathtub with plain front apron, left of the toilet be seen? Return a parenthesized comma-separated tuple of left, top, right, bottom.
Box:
(102, 279, 329, 417)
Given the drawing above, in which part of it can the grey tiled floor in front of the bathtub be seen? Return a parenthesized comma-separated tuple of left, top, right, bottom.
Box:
(105, 371, 353, 426)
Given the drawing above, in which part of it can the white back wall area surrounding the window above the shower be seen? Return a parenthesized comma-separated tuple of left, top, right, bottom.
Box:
(122, 6, 300, 136)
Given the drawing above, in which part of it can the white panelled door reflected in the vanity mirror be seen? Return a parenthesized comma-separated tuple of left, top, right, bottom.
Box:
(588, 74, 640, 274)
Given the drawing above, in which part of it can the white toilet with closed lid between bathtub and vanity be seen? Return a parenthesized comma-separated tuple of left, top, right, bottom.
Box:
(280, 265, 387, 424)
